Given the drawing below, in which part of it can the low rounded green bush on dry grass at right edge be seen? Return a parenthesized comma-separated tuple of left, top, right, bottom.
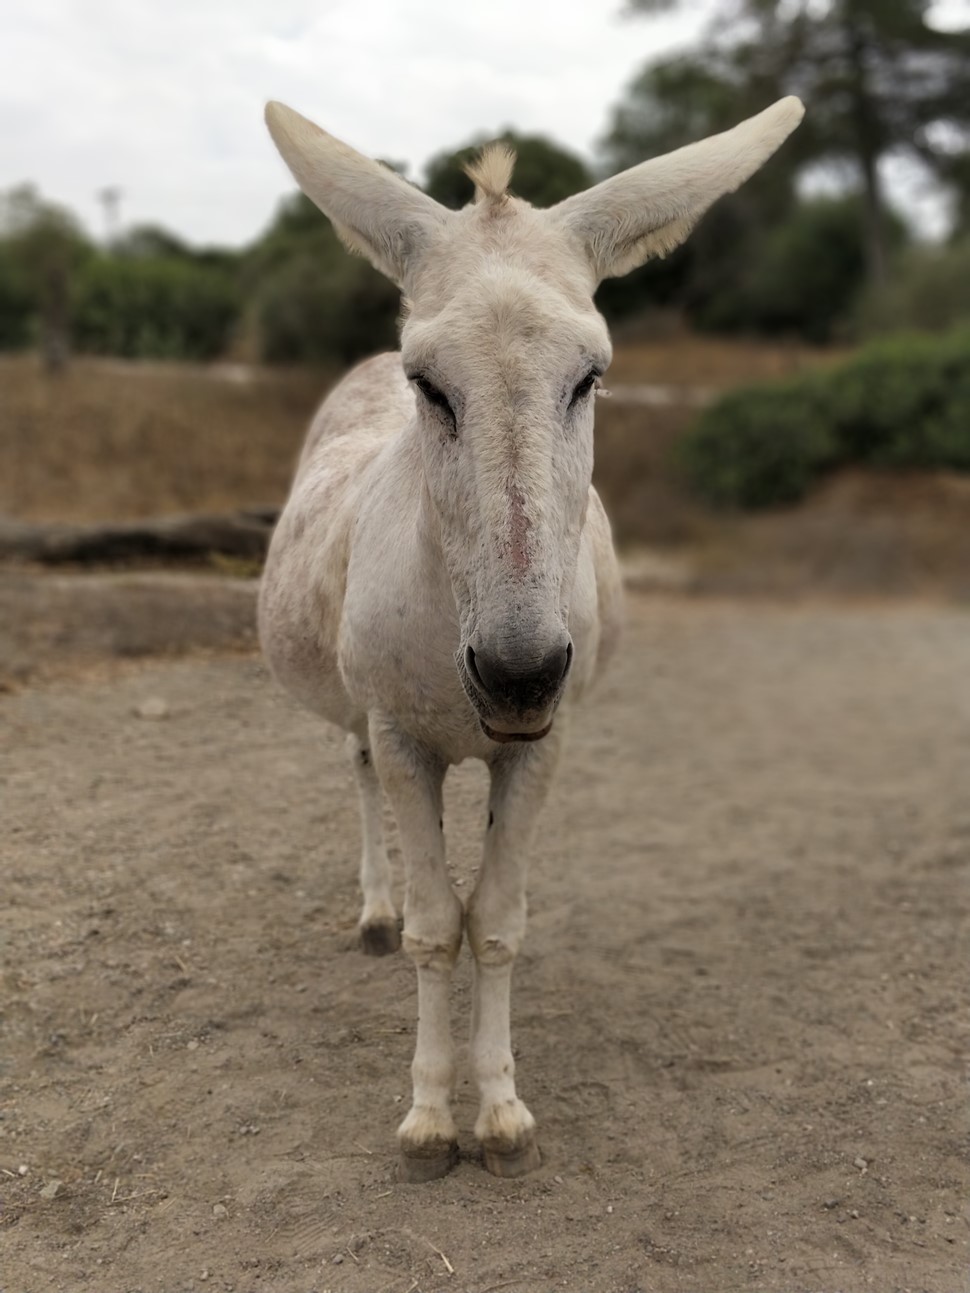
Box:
(679, 330, 970, 508)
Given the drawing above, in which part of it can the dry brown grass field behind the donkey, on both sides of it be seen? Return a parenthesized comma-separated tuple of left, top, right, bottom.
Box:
(7, 340, 970, 596)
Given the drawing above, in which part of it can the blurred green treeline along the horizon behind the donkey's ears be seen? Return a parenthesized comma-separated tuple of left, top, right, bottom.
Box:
(0, 0, 970, 366)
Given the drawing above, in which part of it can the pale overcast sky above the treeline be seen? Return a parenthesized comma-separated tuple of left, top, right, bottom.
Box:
(0, 0, 967, 244)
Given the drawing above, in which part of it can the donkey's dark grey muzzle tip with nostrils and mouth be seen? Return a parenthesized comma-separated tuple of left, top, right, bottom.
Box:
(464, 639, 573, 740)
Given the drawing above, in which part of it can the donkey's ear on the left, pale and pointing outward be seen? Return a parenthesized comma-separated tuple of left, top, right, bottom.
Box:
(266, 103, 450, 290)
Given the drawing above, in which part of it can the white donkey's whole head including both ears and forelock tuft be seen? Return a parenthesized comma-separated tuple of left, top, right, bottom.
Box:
(266, 98, 802, 741)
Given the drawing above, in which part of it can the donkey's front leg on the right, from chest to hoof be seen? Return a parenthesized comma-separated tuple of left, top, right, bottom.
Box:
(466, 733, 559, 1177)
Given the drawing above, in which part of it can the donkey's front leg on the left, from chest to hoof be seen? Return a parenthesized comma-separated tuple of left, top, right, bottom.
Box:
(370, 715, 462, 1181)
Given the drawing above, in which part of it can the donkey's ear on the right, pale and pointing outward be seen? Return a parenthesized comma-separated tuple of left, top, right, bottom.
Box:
(550, 97, 804, 282)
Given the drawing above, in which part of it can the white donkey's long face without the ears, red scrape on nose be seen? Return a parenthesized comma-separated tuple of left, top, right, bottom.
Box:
(401, 206, 610, 741)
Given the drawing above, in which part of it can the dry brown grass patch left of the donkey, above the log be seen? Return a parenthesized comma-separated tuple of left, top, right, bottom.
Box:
(0, 357, 327, 521)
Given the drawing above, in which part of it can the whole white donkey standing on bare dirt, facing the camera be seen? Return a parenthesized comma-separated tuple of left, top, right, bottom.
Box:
(260, 98, 802, 1181)
